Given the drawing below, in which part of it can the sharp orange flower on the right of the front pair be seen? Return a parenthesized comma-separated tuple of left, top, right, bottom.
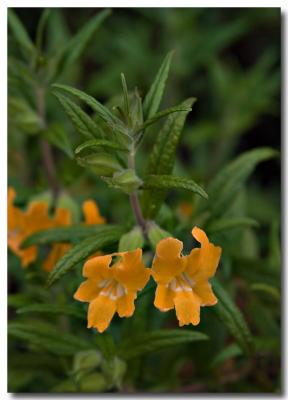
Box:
(151, 227, 222, 326)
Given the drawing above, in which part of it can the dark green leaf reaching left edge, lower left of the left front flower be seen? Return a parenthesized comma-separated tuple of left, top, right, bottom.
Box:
(8, 320, 91, 355)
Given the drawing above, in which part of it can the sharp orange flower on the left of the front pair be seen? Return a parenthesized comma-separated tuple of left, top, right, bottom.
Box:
(74, 249, 150, 333)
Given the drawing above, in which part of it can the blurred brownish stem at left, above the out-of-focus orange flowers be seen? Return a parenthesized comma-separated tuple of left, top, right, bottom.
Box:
(36, 87, 60, 198)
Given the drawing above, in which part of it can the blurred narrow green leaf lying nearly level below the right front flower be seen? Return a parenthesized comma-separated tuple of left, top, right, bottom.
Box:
(119, 328, 208, 360)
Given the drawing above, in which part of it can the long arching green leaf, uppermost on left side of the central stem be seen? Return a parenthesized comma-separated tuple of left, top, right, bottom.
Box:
(52, 83, 128, 135)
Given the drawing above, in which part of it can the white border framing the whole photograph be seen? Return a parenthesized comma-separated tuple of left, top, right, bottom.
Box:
(0, 0, 288, 400)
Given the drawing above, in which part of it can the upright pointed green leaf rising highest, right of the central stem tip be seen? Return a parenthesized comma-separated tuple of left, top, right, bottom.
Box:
(143, 51, 173, 119)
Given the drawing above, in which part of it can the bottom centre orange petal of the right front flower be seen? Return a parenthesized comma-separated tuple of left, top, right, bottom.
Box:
(174, 291, 201, 326)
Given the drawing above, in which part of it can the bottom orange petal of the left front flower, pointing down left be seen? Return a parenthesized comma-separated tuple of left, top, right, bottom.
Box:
(87, 295, 116, 333)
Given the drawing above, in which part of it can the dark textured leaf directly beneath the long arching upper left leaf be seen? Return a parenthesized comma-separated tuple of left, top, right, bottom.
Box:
(52, 92, 103, 139)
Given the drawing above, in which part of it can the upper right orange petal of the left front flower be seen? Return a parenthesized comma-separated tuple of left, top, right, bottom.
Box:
(112, 249, 150, 291)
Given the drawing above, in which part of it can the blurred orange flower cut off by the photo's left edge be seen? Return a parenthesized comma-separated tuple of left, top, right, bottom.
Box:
(8, 188, 52, 268)
